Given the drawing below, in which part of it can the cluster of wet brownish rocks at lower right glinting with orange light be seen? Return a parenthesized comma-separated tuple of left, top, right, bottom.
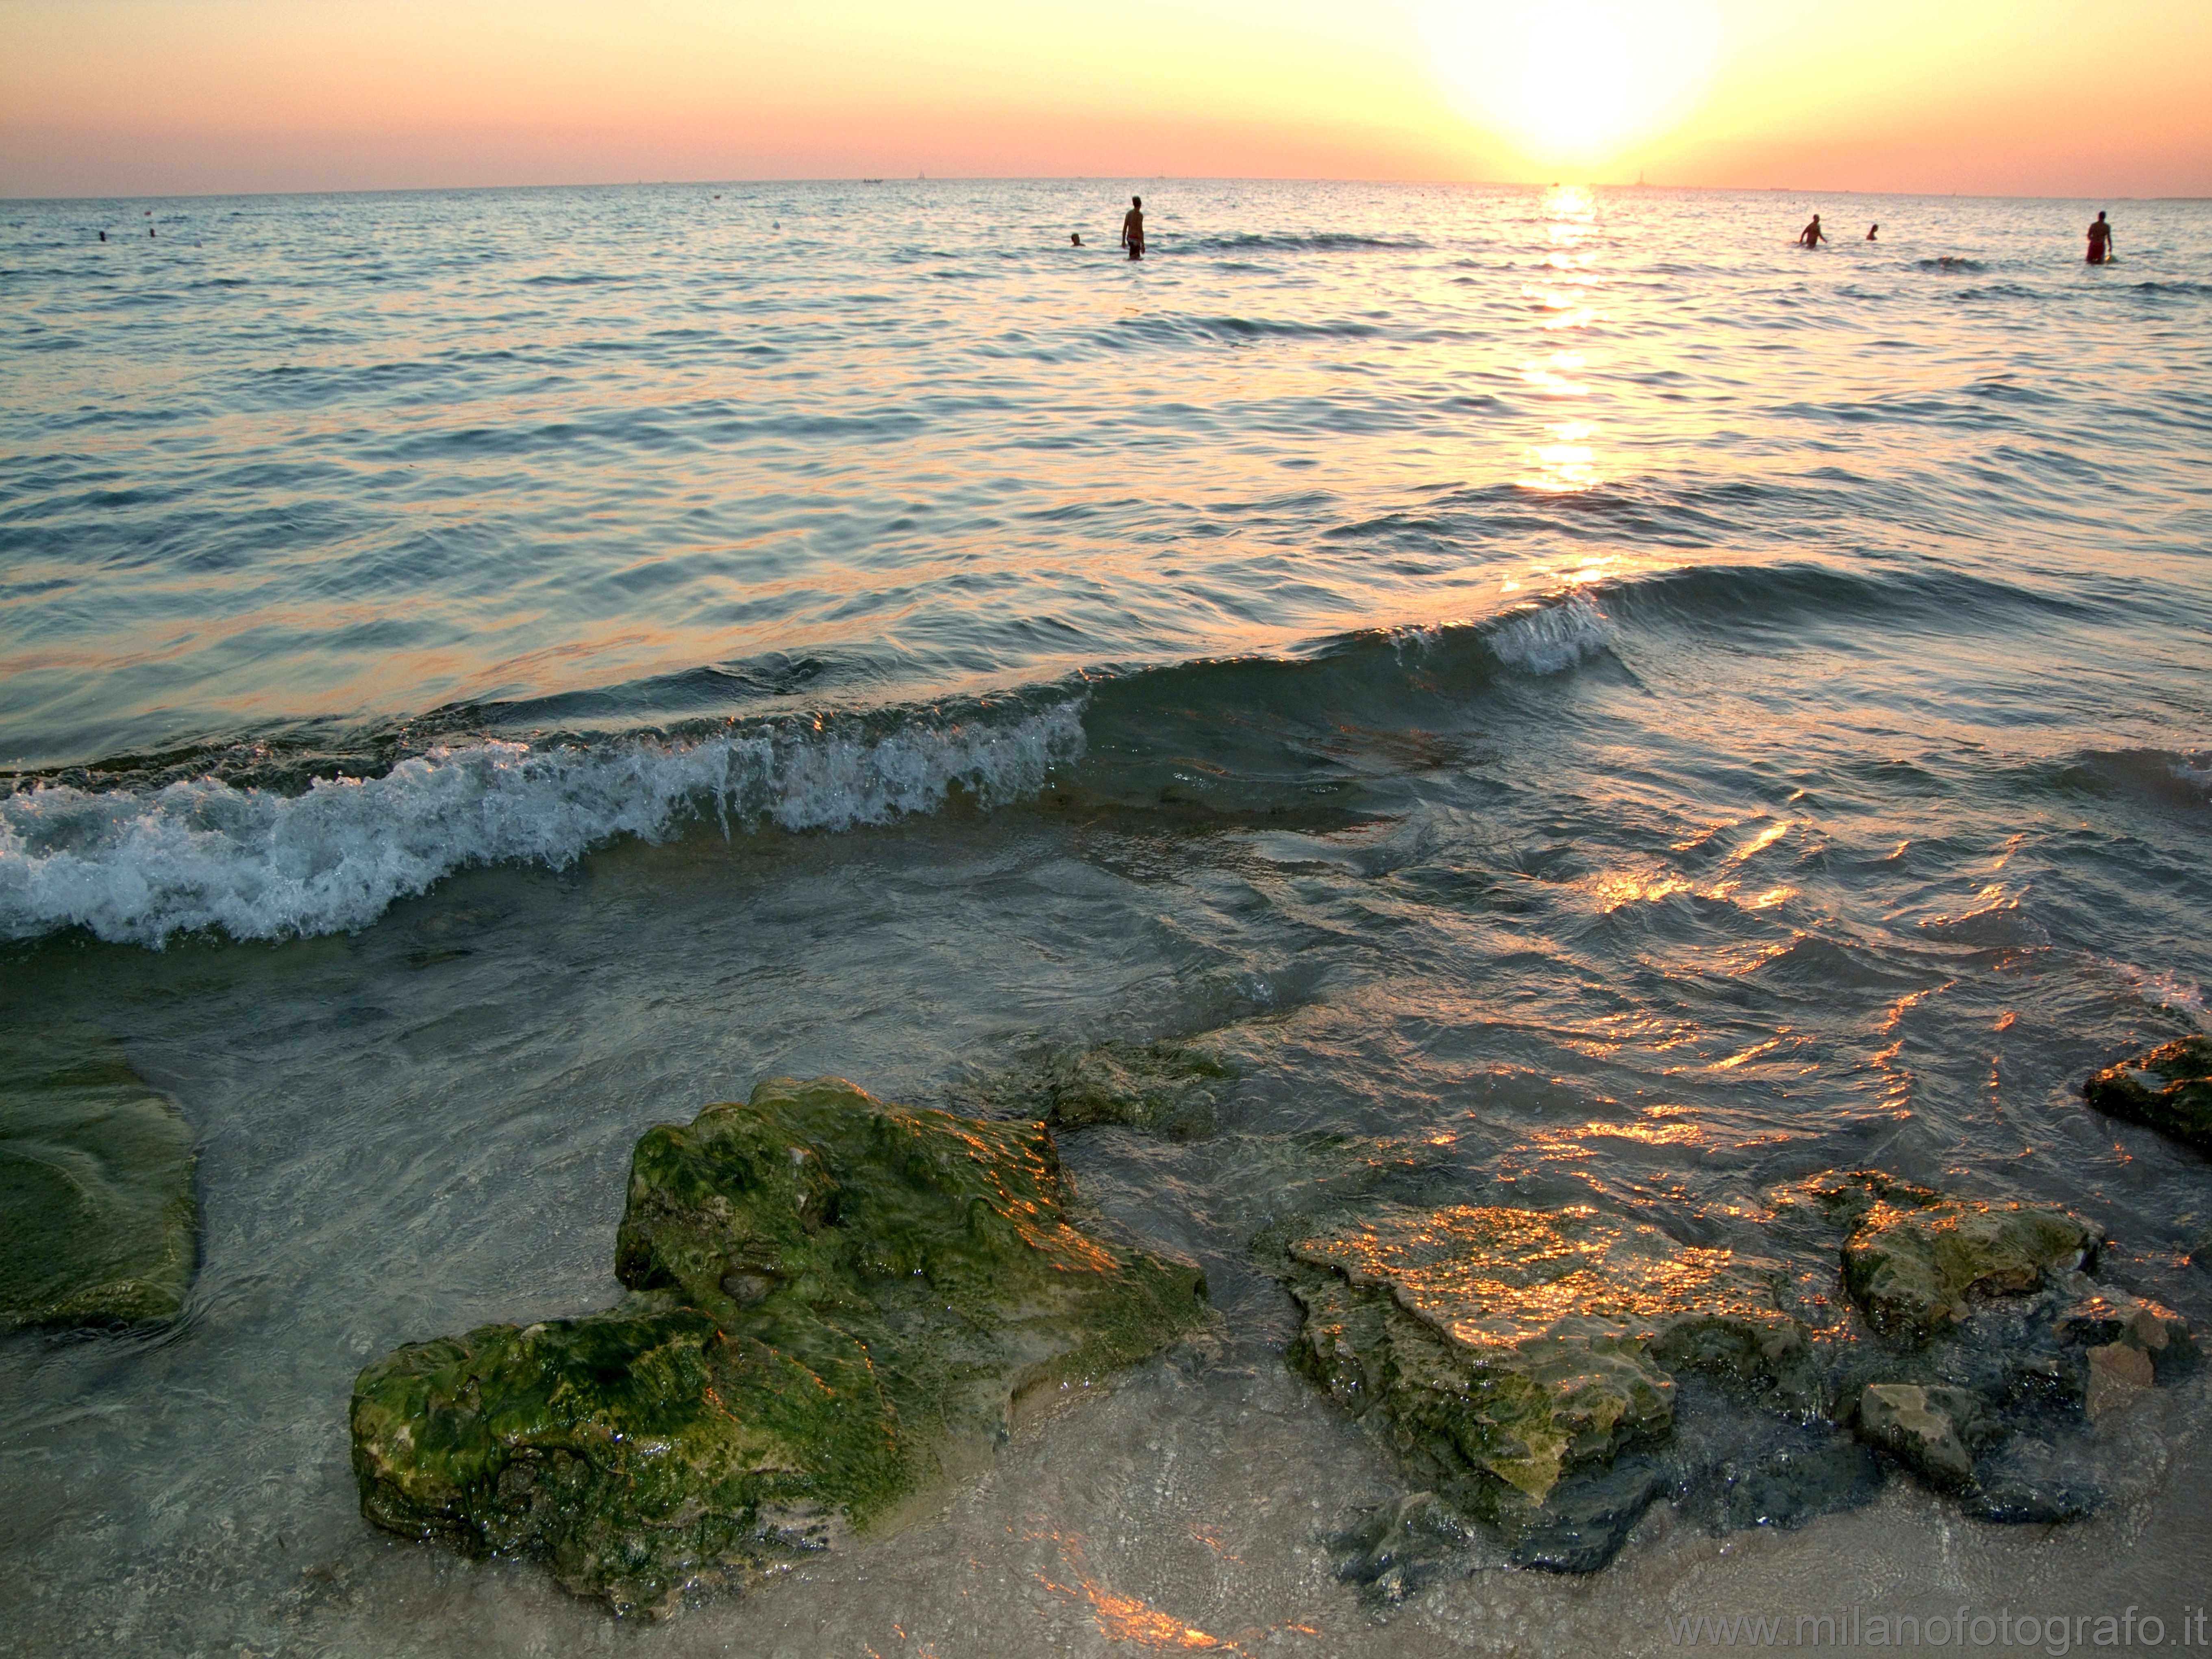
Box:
(1254, 1170, 2197, 1599)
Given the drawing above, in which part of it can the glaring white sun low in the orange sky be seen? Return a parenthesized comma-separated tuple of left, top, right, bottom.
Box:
(1431, 0, 1721, 166)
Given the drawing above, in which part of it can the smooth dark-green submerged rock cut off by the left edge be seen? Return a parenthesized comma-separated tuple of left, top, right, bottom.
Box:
(0, 1029, 199, 1325)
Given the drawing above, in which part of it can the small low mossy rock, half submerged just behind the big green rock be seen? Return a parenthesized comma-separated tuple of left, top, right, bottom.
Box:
(960, 1042, 1237, 1139)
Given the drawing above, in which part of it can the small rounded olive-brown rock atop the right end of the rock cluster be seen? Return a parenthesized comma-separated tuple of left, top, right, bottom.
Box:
(1842, 1188, 2097, 1341)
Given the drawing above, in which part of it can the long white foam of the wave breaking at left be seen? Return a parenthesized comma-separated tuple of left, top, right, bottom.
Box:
(0, 703, 1084, 947)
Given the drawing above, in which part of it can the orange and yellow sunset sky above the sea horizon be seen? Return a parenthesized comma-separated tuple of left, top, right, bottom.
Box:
(0, 0, 2212, 199)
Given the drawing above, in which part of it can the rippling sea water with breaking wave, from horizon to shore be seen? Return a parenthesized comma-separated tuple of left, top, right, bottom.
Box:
(0, 179, 2212, 1659)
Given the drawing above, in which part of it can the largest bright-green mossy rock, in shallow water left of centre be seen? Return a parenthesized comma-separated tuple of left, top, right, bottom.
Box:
(352, 1077, 1210, 1613)
